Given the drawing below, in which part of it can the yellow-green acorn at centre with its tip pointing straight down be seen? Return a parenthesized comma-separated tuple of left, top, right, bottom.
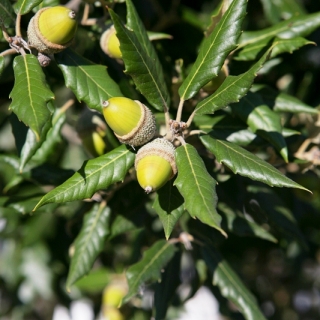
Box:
(135, 138, 177, 193)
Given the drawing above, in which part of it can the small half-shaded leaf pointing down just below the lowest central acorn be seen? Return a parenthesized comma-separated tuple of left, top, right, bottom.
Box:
(153, 180, 184, 240)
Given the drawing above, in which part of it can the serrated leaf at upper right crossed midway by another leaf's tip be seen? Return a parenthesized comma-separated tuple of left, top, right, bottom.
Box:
(235, 37, 315, 61)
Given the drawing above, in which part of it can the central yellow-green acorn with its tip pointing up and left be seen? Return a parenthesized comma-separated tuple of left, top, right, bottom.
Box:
(102, 97, 157, 147)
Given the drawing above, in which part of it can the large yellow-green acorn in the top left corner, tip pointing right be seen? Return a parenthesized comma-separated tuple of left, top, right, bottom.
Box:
(27, 6, 77, 54)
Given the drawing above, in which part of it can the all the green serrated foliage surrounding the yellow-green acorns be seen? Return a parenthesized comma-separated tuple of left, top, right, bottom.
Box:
(0, 0, 320, 320)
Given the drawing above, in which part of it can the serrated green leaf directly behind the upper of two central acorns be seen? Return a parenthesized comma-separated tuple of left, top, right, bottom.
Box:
(56, 49, 123, 112)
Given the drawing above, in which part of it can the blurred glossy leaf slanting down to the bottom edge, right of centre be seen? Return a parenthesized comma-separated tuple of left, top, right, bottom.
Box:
(202, 246, 266, 320)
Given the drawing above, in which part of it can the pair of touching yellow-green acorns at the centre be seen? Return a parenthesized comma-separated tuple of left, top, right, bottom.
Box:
(103, 97, 177, 193)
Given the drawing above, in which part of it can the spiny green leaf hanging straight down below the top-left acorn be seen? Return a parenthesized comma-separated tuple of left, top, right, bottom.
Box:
(10, 54, 54, 140)
